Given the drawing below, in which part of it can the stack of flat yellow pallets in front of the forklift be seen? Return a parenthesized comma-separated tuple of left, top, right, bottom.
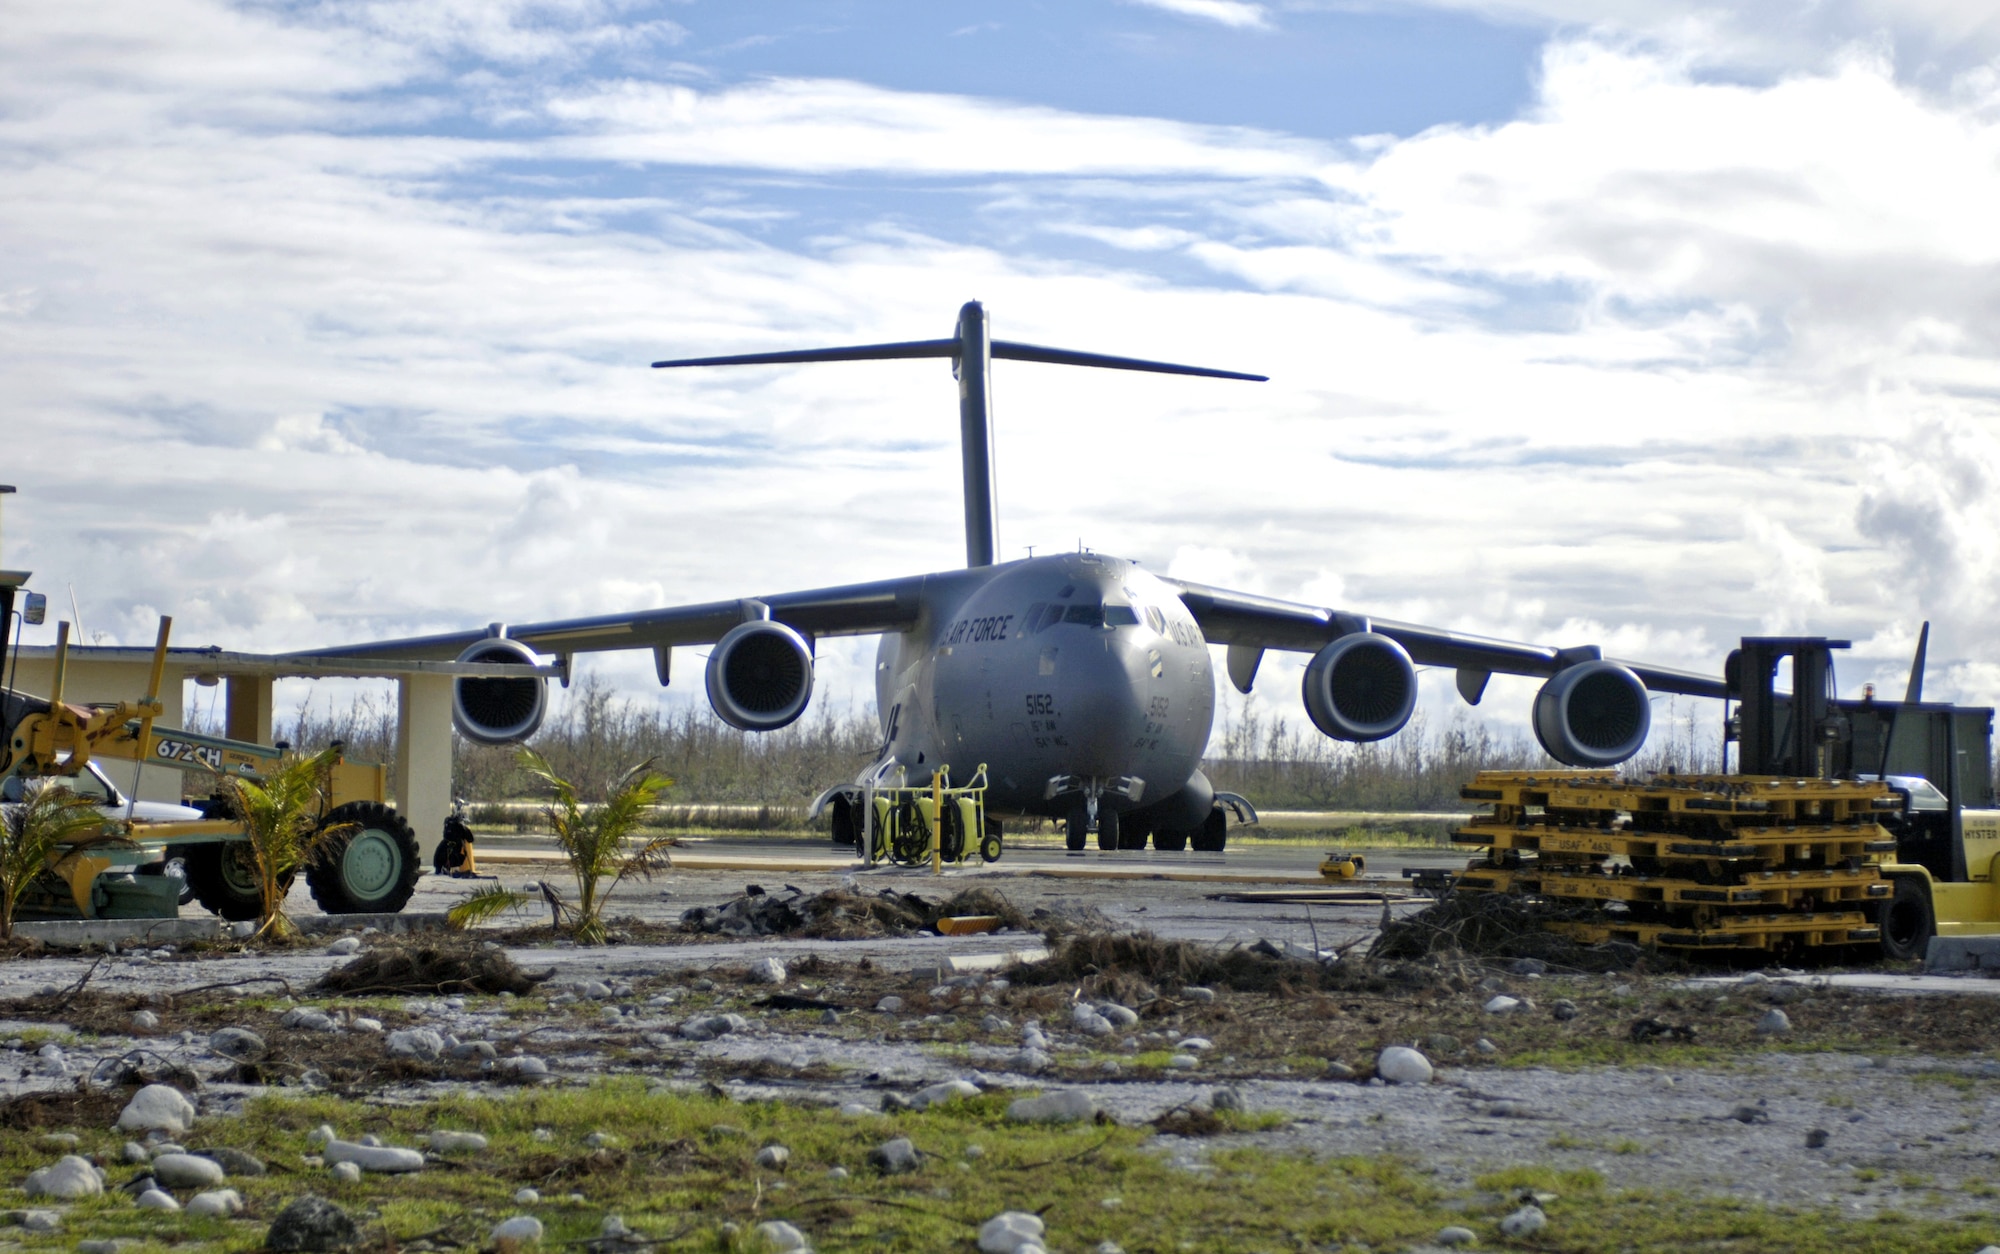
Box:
(1452, 770, 1898, 950)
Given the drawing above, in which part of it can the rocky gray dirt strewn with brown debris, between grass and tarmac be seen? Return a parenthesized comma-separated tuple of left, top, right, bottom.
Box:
(0, 876, 2000, 1248)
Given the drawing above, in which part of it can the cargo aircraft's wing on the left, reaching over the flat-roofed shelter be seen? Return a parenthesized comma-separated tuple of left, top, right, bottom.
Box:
(286, 574, 950, 662)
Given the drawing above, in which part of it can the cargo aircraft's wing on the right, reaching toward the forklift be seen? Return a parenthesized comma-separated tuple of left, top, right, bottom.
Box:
(1164, 578, 1724, 698)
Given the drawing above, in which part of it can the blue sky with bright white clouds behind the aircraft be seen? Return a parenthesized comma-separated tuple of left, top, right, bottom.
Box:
(0, 0, 2000, 744)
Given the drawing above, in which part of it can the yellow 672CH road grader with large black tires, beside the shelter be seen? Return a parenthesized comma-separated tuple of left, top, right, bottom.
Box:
(0, 618, 420, 920)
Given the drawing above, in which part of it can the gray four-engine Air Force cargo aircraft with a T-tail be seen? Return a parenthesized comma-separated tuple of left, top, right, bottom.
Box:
(302, 302, 1724, 852)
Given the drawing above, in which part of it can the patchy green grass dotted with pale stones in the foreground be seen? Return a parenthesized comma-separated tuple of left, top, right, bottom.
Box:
(0, 1080, 2000, 1254)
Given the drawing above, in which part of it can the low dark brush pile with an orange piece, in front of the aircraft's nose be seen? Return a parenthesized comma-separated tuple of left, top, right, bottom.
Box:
(680, 884, 1060, 940)
